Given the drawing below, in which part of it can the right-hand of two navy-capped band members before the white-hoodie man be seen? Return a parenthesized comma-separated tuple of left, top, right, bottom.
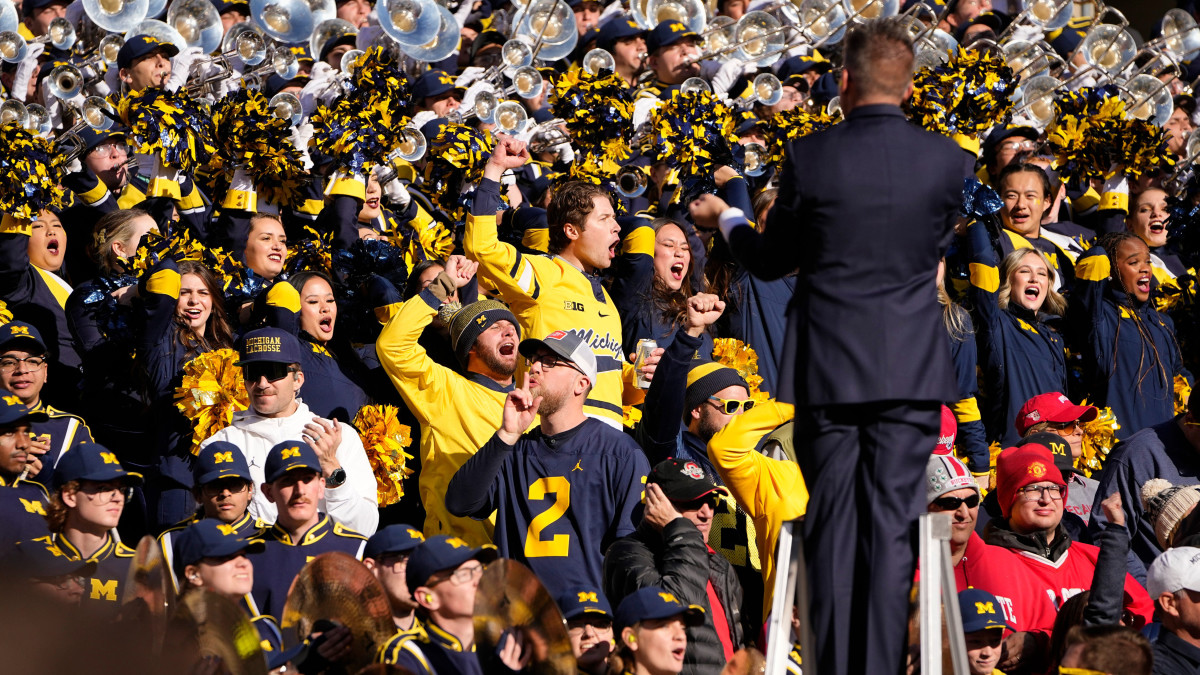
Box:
(251, 441, 366, 619)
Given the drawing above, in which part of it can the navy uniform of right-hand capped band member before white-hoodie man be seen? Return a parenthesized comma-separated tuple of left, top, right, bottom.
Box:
(251, 513, 367, 619)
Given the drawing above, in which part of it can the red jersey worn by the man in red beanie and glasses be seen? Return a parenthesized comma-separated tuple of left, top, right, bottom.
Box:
(968, 530, 1154, 637)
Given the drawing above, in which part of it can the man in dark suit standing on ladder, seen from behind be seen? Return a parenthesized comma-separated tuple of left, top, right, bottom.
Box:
(690, 19, 973, 675)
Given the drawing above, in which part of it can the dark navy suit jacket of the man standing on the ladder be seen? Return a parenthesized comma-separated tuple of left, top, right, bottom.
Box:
(730, 104, 973, 406)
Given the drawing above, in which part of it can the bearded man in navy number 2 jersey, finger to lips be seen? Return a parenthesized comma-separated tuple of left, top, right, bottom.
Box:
(446, 330, 650, 597)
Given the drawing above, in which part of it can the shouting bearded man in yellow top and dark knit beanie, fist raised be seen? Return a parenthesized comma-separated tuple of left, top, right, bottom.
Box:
(376, 256, 521, 546)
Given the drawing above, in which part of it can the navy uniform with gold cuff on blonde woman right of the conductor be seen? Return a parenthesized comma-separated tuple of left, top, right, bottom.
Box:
(967, 222, 1067, 444)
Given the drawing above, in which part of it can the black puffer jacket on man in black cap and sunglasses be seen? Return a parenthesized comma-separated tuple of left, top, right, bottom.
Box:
(604, 518, 746, 675)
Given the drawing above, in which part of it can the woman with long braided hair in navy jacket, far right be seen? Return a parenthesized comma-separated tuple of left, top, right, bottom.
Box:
(1069, 231, 1192, 438)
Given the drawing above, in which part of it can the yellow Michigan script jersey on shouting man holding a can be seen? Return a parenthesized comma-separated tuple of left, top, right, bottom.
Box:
(463, 178, 641, 429)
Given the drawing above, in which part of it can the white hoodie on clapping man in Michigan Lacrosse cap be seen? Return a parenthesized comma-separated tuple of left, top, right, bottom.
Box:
(200, 401, 379, 537)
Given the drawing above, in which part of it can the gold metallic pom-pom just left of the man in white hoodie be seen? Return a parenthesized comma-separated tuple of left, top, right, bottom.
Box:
(175, 348, 250, 454)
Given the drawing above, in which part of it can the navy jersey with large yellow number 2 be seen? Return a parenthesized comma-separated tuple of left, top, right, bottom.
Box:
(446, 418, 650, 597)
